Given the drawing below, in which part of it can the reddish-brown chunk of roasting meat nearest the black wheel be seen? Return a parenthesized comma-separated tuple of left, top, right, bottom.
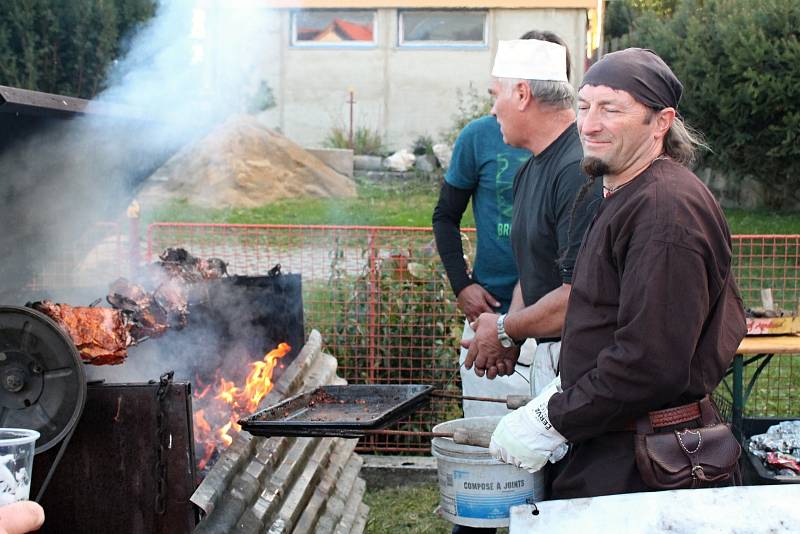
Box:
(29, 300, 134, 365)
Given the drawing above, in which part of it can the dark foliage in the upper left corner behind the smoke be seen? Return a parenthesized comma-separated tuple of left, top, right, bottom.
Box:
(0, 0, 156, 98)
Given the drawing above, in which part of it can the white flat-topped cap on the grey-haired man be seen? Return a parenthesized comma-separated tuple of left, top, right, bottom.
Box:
(492, 39, 568, 82)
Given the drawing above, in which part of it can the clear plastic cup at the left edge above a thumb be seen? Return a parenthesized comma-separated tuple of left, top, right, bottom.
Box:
(0, 428, 39, 506)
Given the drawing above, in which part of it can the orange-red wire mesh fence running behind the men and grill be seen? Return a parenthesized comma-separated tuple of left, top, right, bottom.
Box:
(146, 223, 800, 452)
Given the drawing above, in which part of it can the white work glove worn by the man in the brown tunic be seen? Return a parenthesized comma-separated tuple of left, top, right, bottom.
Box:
(489, 377, 568, 473)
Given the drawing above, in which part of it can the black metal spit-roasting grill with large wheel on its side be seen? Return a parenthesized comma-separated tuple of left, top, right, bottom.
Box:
(0, 275, 305, 534)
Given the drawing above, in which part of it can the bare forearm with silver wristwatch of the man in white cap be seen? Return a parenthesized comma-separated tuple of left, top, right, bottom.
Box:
(505, 284, 572, 339)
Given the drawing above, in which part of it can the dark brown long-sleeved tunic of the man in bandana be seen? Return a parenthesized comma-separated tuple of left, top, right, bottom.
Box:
(548, 160, 746, 498)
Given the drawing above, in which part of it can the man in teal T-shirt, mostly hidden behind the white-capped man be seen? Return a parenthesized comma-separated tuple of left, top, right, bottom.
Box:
(433, 30, 570, 428)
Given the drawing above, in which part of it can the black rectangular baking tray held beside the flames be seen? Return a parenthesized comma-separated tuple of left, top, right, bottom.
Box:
(239, 384, 433, 438)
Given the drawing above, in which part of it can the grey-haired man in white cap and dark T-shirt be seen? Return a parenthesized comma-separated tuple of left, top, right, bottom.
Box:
(465, 39, 600, 402)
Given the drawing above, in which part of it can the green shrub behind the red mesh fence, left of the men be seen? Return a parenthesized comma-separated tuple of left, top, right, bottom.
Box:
(331, 244, 462, 383)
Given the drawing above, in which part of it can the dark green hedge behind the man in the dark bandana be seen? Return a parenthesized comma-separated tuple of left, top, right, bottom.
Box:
(624, 0, 800, 208)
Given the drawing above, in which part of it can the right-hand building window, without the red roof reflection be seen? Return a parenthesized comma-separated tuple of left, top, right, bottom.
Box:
(398, 10, 486, 47)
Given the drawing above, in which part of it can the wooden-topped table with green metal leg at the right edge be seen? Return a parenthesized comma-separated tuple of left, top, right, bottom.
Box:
(726, 334, 800, 441)
